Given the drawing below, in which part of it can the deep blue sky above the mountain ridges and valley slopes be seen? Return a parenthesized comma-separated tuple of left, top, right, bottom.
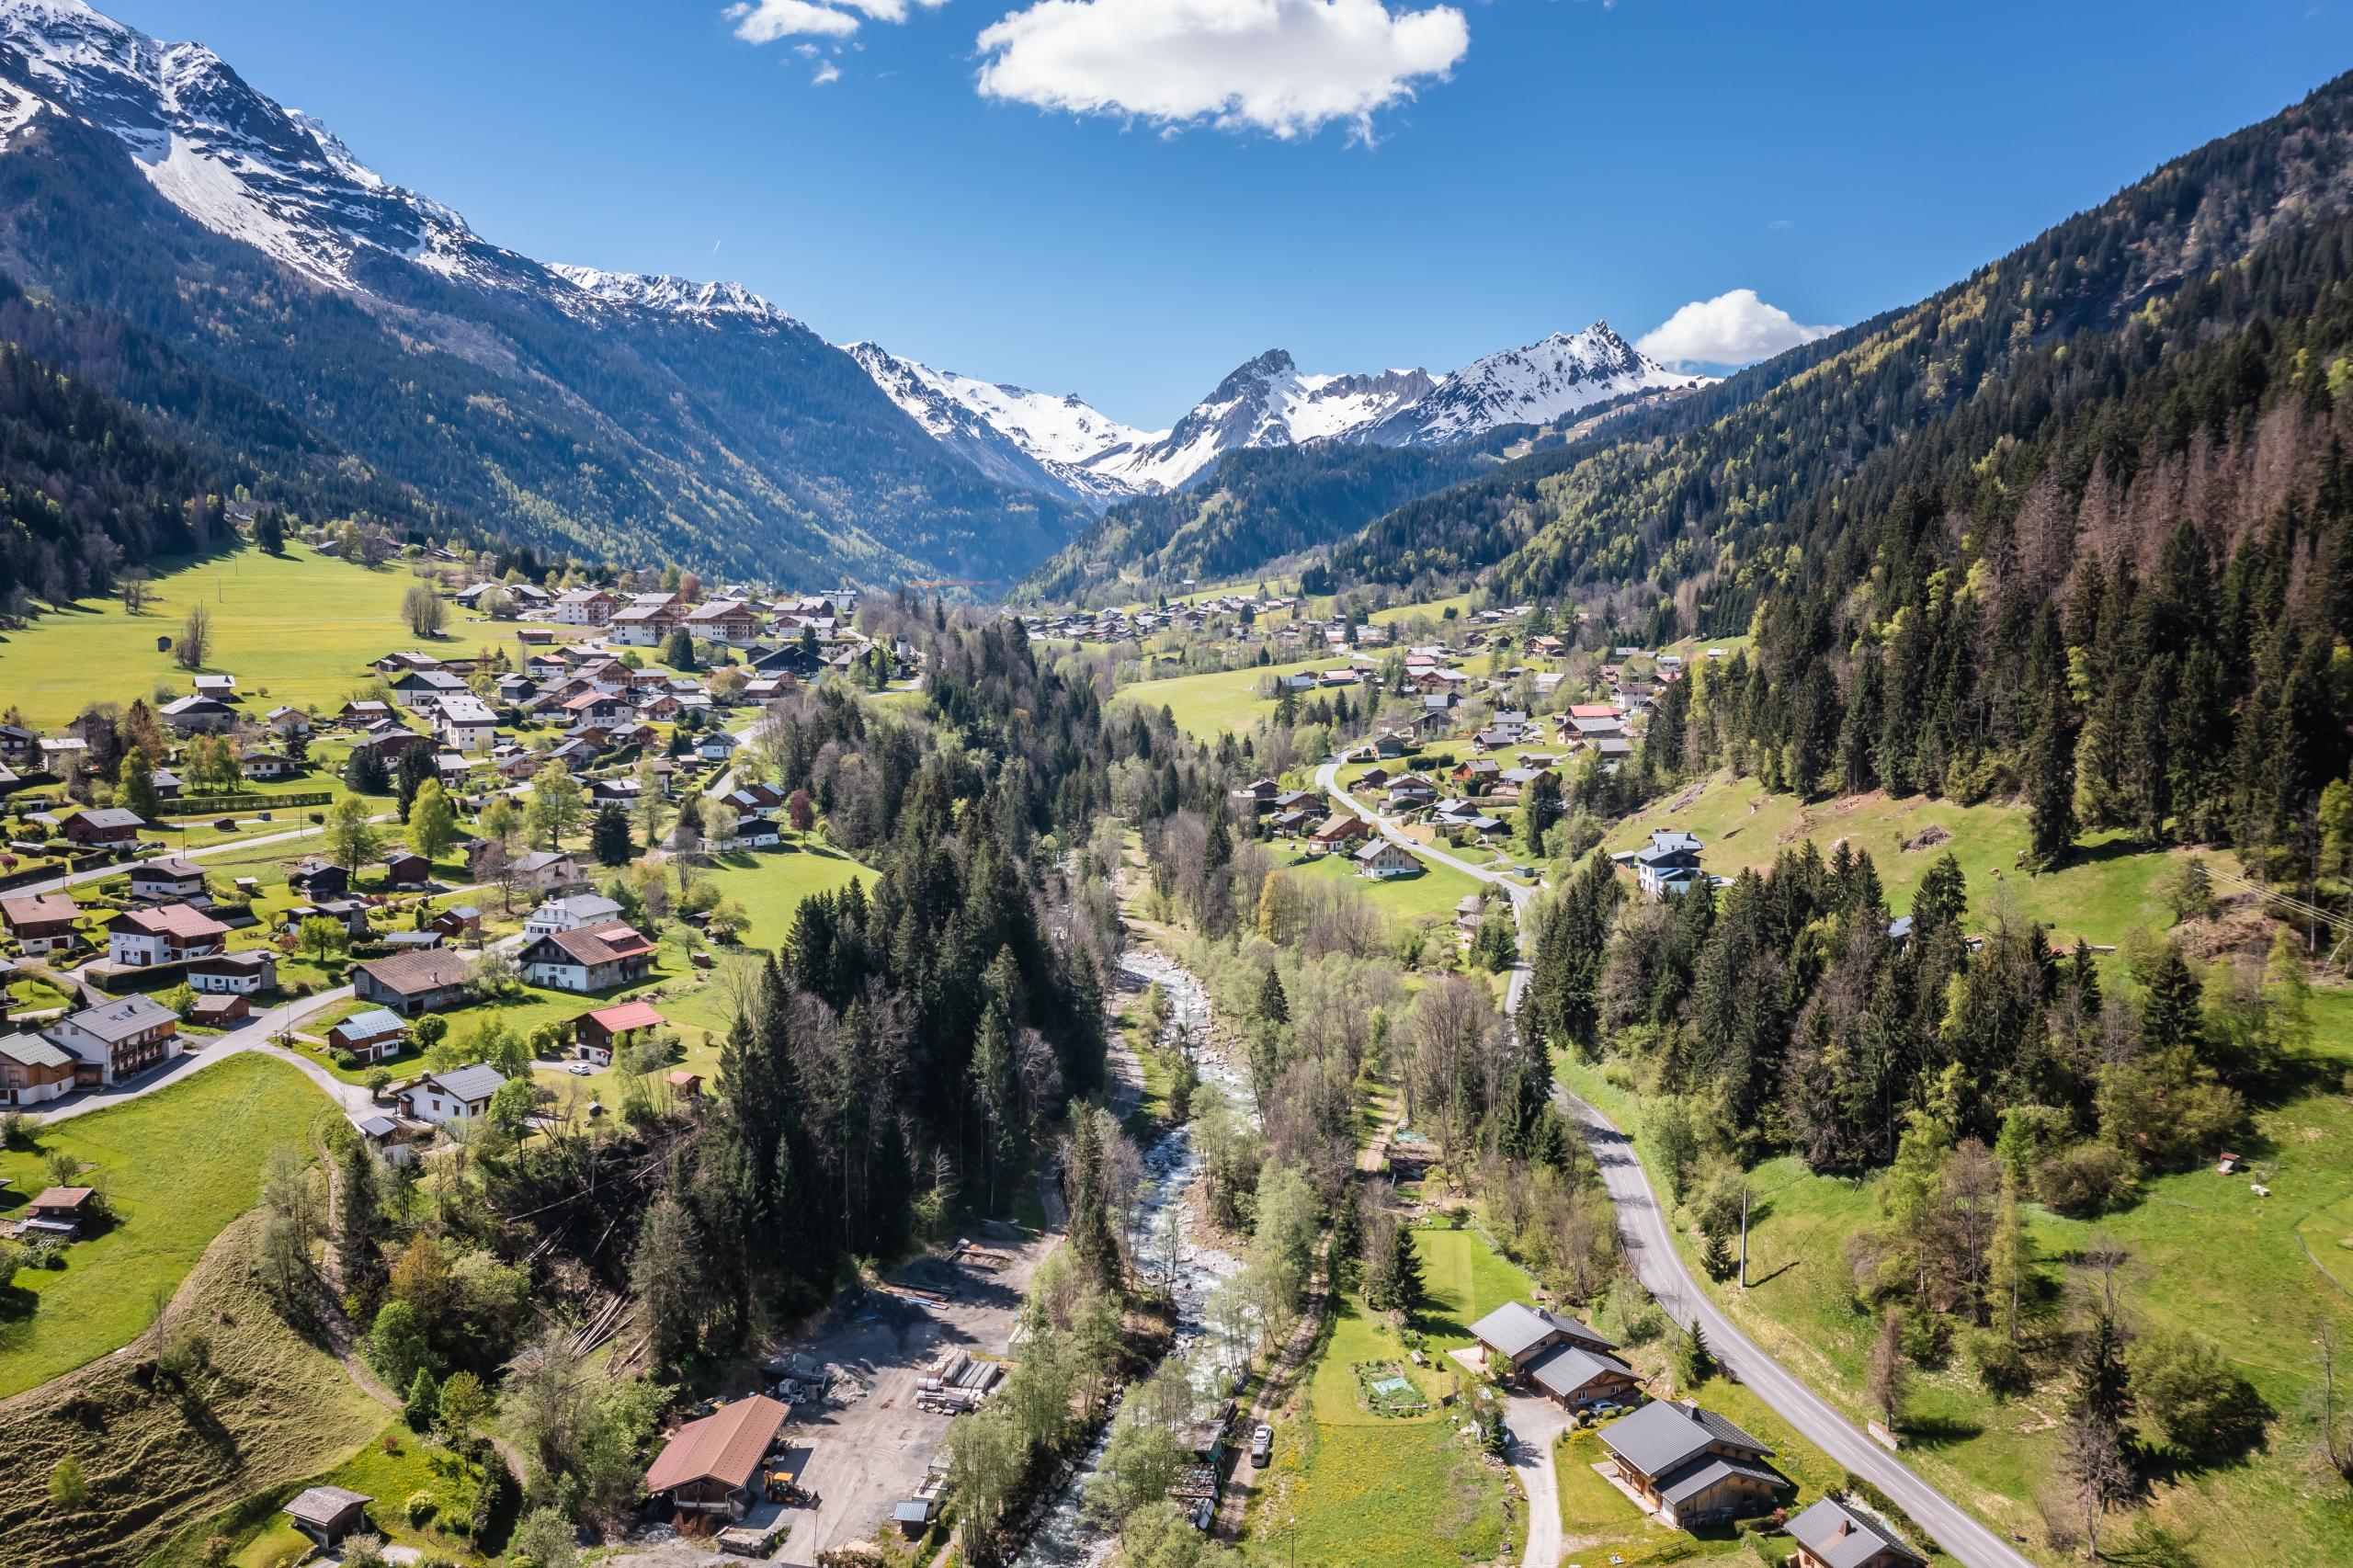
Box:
(114, 0, 2353, 426)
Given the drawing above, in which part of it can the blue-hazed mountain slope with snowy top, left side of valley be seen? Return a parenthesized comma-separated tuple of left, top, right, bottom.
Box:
(0, 0, 1085, 582)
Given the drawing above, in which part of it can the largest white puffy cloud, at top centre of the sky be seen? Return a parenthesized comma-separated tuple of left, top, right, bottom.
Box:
(979, 0, 1471, 137)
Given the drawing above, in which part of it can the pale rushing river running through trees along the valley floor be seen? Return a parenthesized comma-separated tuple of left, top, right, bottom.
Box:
(1014, 951, 1256, 1568)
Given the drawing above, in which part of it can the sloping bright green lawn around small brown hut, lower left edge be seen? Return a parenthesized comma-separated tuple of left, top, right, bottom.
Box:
(0, 1055, 327, 1396)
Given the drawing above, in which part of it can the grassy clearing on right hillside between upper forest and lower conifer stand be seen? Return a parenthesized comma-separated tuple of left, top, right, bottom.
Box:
(1605, 775, 2238, 944)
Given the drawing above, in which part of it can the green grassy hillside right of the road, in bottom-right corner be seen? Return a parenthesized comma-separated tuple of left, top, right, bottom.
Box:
(1560, 989, 2353, 1563)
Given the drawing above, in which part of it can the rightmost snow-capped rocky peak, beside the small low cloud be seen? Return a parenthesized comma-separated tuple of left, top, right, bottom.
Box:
(1356, 320, 1709, 448)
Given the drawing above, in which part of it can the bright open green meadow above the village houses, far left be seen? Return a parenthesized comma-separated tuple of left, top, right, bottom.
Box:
(0, 544, 430, 725)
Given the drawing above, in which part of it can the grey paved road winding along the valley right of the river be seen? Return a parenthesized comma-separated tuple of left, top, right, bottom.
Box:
(1315, 760, 2030, 1568)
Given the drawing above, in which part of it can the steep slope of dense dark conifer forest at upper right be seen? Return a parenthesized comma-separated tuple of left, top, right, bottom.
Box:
(1335, 67, 2353, 857)
